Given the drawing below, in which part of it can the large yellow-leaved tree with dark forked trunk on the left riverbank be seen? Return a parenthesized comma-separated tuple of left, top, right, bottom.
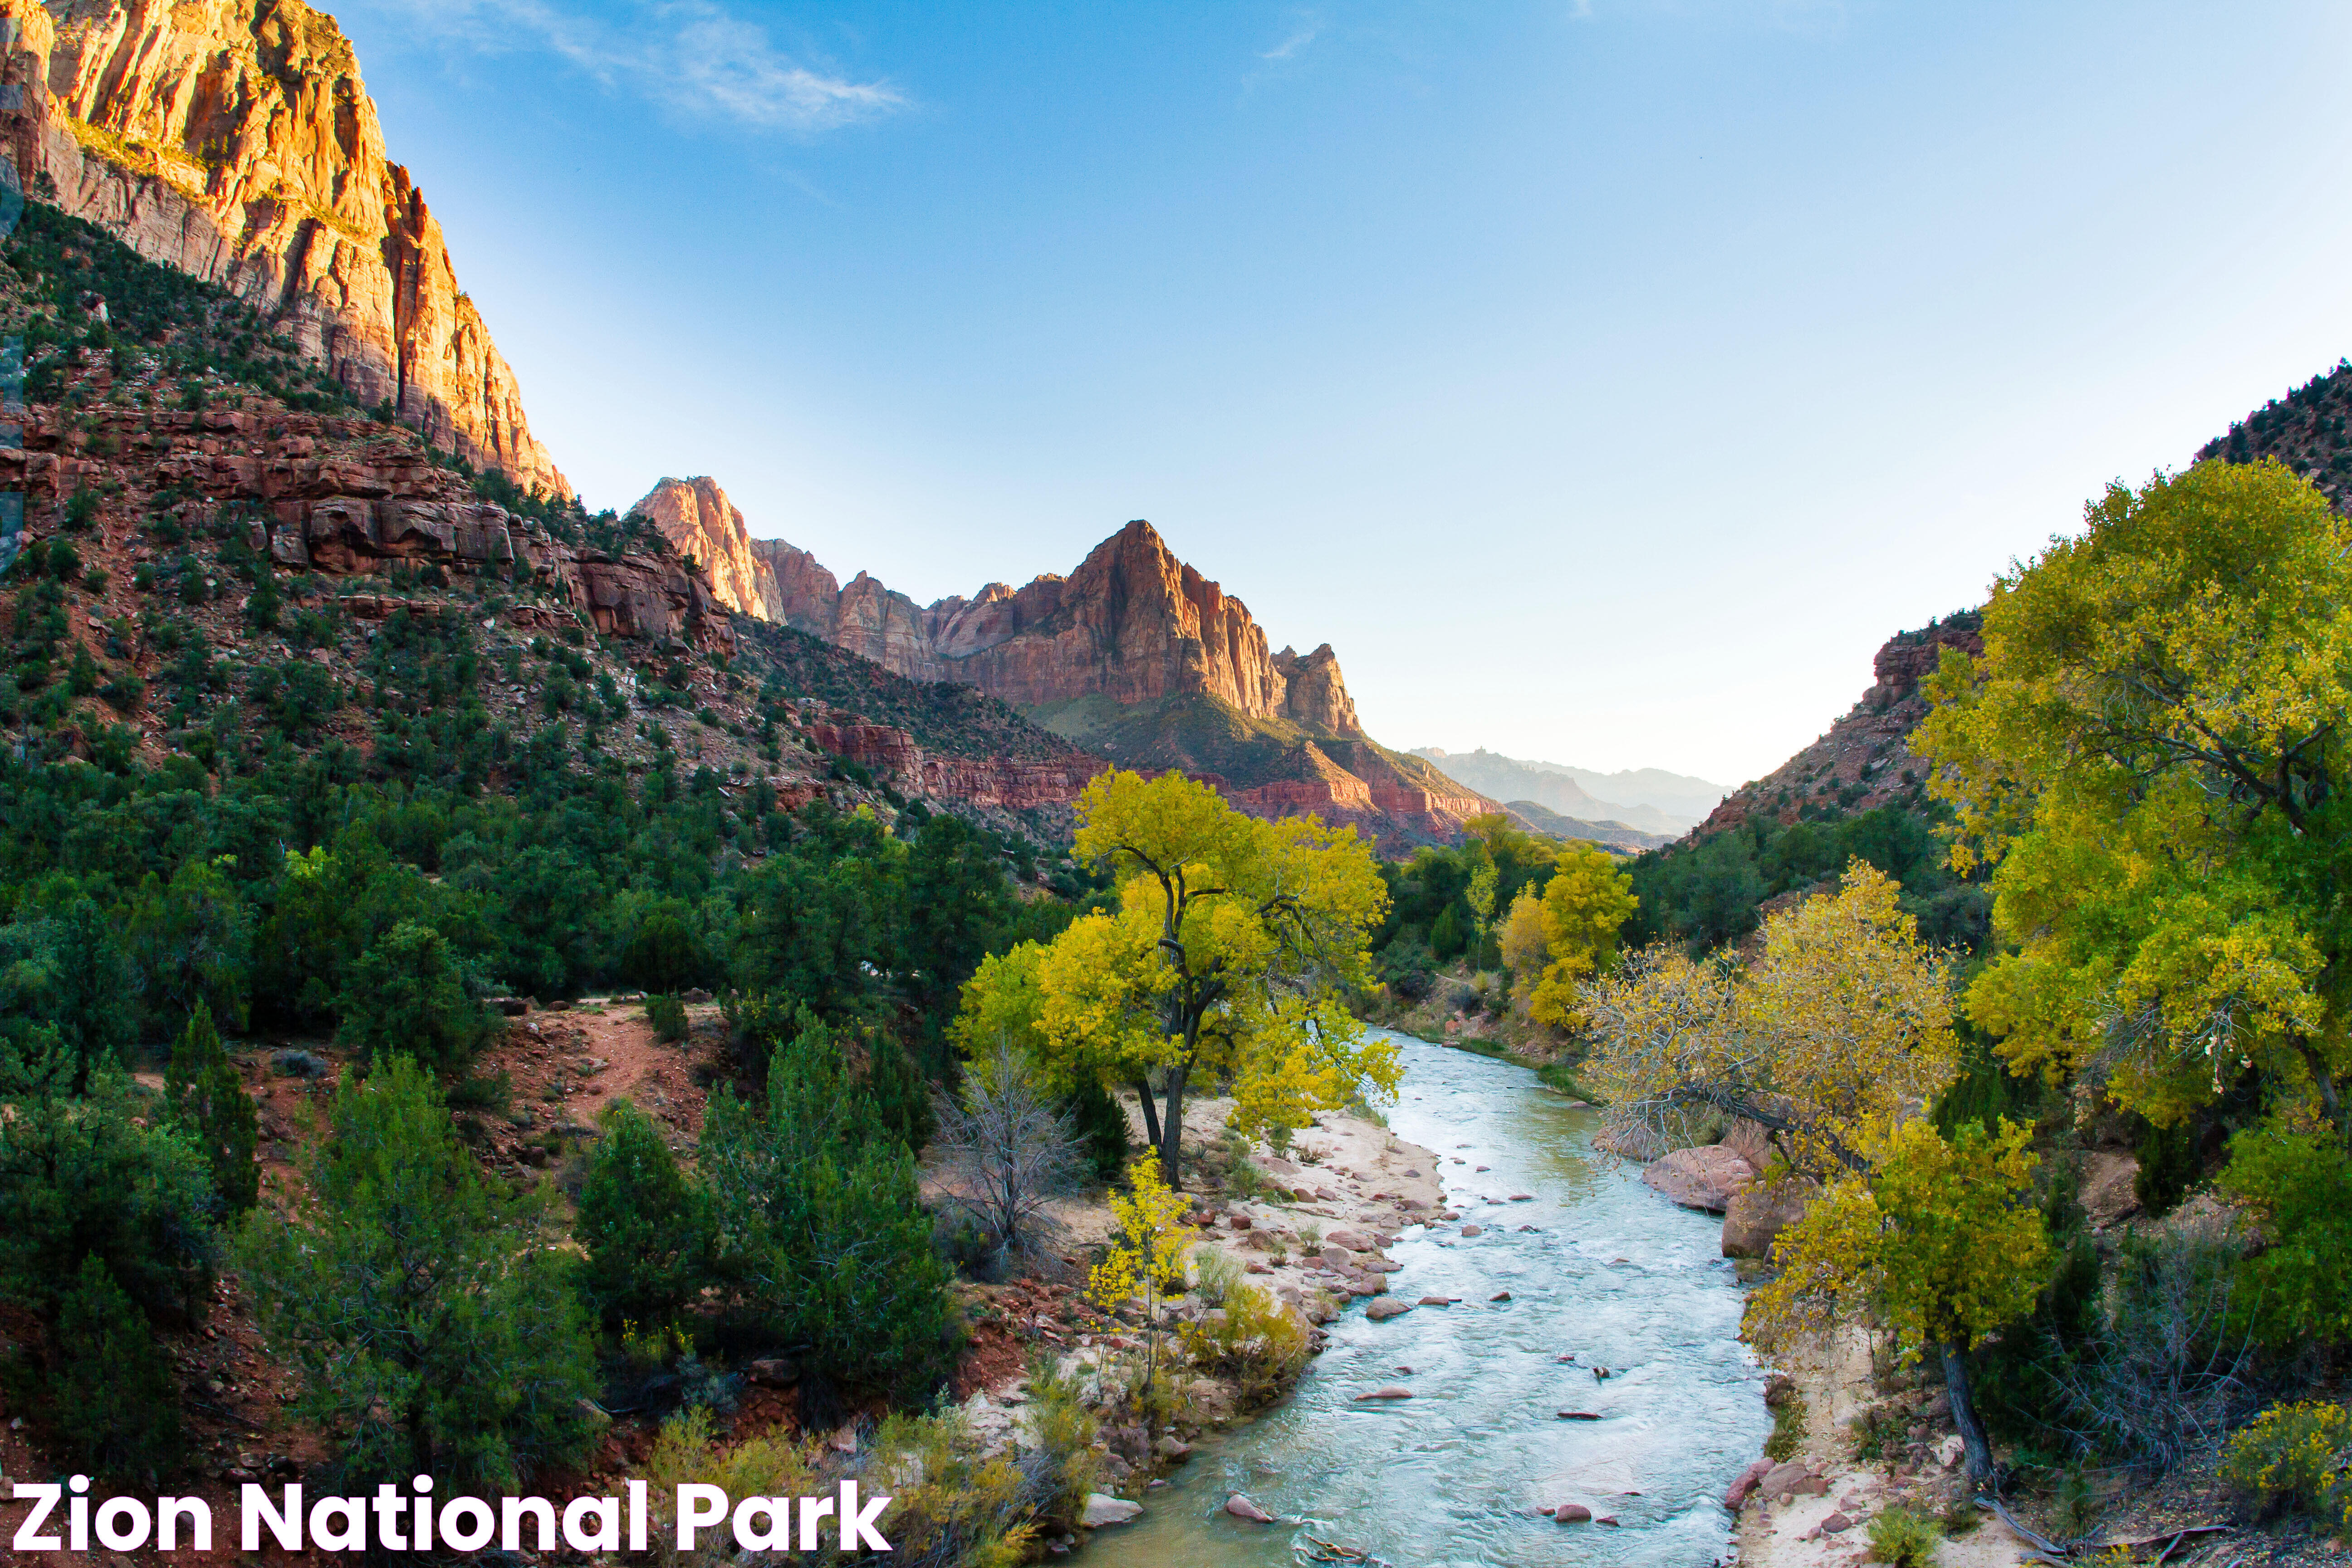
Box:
(953, 771, 1399, 1190)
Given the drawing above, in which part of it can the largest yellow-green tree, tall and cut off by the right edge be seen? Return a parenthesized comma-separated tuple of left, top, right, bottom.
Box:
(1912, 461, 2352, 1131)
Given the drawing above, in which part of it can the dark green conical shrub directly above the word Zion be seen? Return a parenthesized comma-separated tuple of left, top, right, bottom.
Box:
(47, 1255, 181, 1479)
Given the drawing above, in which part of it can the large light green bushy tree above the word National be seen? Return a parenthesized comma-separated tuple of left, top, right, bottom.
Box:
(238, 1055, 595, 1490)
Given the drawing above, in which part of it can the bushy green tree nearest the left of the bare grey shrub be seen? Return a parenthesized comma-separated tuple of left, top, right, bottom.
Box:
(696, 1018, 948, 1399)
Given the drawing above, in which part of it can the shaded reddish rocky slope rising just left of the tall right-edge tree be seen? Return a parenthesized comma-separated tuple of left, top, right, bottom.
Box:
(1696, 609, 1985, 837)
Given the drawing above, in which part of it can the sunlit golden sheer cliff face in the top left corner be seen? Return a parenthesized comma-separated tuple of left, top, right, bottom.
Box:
(0, 0, 569, 494)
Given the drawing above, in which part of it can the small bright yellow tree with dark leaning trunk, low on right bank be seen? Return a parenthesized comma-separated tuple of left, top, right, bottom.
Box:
(1748, 1117, 2048, 1481)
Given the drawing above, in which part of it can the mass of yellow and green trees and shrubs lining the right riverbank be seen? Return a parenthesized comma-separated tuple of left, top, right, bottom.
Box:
(1376, 461, 2352, 1561)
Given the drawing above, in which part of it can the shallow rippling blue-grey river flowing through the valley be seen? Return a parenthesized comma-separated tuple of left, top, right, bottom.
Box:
(1079, 1034, 1771, 1568)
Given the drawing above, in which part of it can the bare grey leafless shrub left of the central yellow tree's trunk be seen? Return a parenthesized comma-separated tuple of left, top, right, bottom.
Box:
(931, 1041, 1079, 1255)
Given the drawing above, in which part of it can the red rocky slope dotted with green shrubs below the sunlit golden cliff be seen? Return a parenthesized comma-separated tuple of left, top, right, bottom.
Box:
(0, 202, 1103, 842)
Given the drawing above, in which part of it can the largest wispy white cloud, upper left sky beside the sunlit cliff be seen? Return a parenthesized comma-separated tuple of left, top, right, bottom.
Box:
(364, 0, 906, 132)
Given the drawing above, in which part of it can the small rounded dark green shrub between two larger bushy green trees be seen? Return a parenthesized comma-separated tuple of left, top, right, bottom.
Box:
(572, 1100, 717, 1323)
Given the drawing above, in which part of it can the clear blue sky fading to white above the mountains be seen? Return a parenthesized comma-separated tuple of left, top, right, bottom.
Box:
(334, 0, 2352, 783)
